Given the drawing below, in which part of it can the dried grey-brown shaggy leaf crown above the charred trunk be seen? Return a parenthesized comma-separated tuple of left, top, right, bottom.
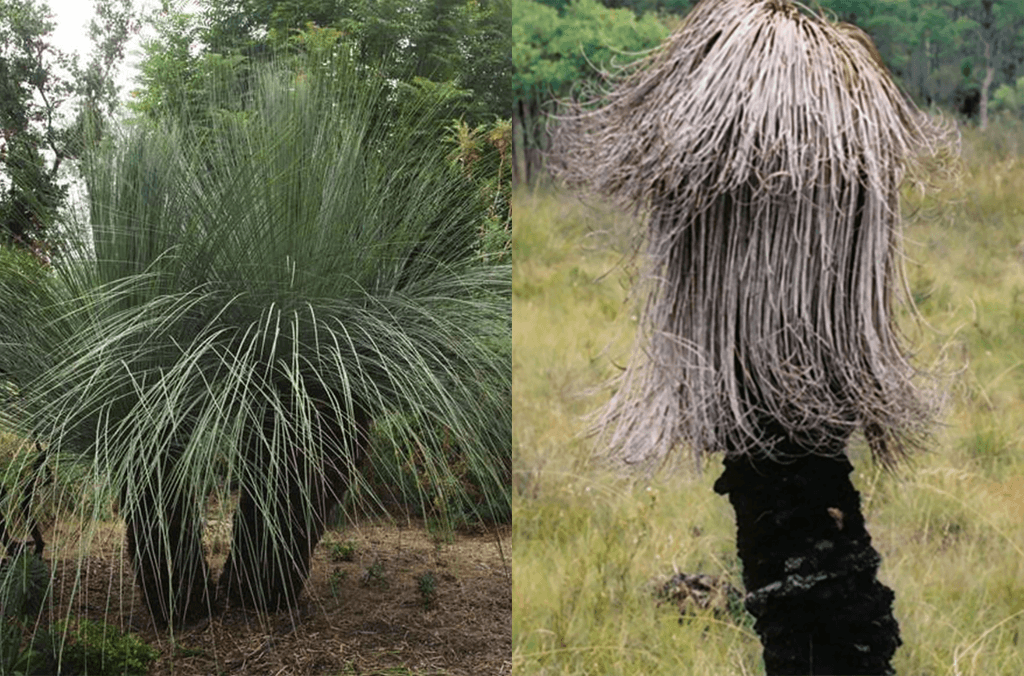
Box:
(551, 0, 955, 464)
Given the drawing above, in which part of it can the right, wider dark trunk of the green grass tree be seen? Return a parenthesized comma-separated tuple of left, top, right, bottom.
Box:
(219, 401, 369, 611)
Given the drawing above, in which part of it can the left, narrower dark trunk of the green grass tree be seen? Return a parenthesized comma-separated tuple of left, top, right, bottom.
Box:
(121, 448, 213, 628)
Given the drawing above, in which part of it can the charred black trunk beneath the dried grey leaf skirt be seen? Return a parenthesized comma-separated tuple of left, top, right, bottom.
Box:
(715, 447, 901, 675)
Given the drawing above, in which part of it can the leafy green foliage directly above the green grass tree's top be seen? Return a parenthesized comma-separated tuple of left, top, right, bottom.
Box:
(133, 0, 511, 124)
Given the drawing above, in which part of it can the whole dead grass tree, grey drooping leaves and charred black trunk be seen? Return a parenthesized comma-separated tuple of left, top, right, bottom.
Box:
(554, 0, 944, 674)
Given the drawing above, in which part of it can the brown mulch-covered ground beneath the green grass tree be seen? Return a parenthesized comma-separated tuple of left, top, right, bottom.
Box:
(37, 514, 512, 676)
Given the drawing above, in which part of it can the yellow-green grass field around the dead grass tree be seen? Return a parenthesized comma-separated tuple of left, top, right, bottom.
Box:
(512, 123, 1024, 676)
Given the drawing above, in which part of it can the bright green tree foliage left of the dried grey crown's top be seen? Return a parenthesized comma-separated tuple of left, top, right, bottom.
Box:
(512, 0, 668, 180)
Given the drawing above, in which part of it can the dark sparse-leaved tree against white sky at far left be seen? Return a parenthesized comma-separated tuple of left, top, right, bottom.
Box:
(0, 0, 133, 260)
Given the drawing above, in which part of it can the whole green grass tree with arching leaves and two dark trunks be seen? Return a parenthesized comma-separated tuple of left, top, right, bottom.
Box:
(0, 58, 511, 625)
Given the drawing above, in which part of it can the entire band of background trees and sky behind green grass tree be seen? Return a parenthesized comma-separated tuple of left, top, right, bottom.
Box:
(0, 0, 512, 259)
